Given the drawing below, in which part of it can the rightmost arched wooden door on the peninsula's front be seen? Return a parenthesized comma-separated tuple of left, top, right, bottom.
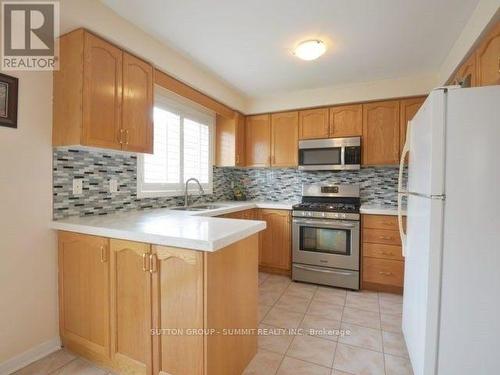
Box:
(152, 246, 204, 375)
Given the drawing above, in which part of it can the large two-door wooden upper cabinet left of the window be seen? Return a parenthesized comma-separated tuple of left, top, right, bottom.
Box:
(52, 29, 153, 153)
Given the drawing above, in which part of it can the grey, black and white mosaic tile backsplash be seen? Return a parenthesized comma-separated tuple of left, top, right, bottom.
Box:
(53, 148, 398, 219)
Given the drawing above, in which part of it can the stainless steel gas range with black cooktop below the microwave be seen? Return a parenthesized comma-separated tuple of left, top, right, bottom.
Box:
(292, 185, 361, 290)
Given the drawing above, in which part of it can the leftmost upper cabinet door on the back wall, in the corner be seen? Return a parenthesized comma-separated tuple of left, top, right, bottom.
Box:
(245, 115, 271, 167)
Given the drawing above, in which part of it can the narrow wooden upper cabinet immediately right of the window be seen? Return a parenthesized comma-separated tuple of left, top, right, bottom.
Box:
(215, 112, 245, 167)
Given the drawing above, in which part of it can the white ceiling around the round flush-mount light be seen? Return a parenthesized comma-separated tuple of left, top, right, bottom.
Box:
(101, 0, 478, 97)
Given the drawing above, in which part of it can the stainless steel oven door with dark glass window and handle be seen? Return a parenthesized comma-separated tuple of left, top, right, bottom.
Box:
(292, 218, 359, 271)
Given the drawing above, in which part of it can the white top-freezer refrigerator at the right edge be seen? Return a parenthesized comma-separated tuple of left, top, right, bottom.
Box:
(399, 86, 500, 375)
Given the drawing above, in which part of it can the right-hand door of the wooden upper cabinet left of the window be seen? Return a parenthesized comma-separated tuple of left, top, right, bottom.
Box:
(122, 52, 153, 154)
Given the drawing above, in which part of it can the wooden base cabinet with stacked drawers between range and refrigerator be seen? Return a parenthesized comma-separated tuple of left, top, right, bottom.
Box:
(361, 215, 404, 293)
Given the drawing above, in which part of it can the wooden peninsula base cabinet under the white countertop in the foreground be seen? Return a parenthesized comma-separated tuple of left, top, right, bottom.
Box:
(59, 232, 259, 375)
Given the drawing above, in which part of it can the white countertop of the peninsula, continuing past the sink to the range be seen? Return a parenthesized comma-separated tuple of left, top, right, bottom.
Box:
(52, 201, 294, 251)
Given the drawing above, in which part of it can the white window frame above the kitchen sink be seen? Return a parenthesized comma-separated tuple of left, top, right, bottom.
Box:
(137, 86, 215, 198)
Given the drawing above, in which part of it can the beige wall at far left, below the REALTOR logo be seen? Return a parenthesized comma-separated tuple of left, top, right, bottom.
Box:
(0, 72, 58, 373)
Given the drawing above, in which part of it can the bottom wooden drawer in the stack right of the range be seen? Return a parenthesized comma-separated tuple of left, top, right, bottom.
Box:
(363, 257, 404, 287)
